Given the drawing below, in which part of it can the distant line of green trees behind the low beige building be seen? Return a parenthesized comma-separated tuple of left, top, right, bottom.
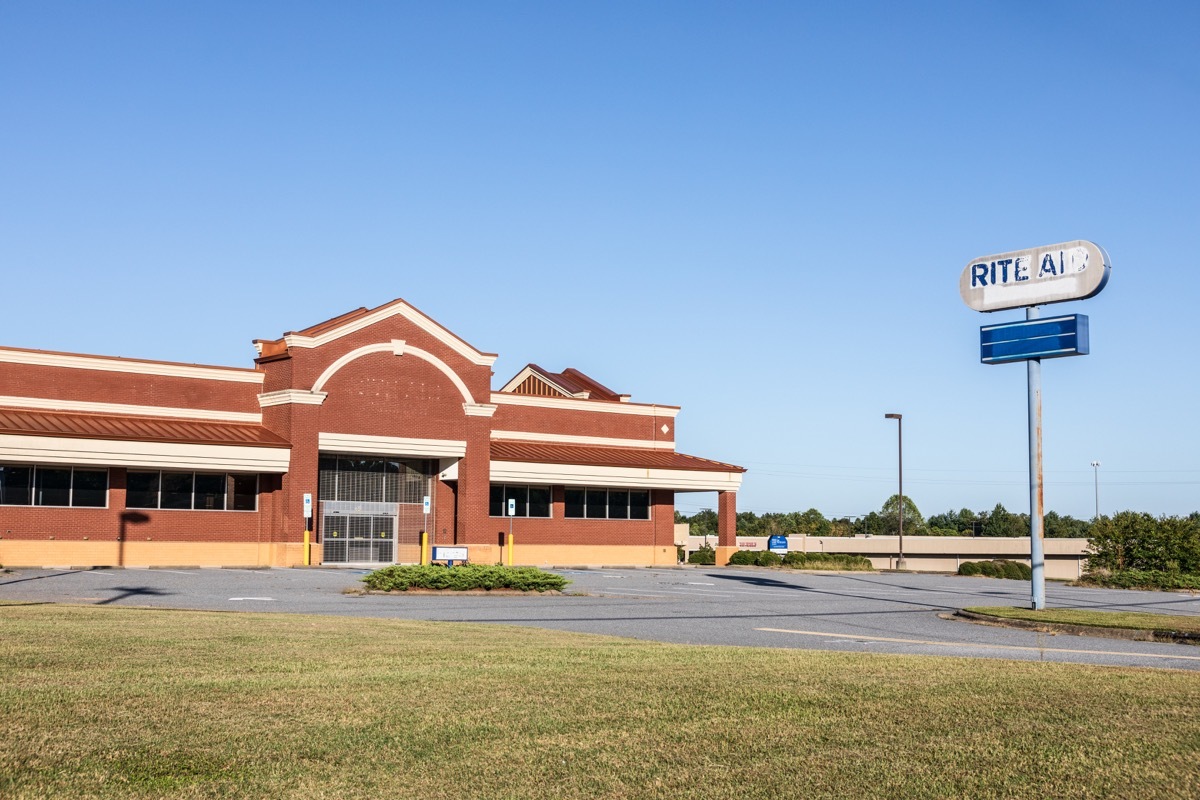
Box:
(676, 494, 1093, 539)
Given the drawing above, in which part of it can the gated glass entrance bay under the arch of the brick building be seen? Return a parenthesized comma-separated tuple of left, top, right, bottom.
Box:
(318, 453, 436, 564)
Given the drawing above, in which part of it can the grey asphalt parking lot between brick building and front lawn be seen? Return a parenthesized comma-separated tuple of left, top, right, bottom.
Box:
(7, 567, 1200, 669)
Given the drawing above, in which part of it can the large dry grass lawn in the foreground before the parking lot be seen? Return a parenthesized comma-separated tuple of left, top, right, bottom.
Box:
(0, 604, 1200, 800)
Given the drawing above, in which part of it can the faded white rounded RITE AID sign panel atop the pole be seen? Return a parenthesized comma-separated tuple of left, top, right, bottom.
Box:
(959, 239, 1112, 311)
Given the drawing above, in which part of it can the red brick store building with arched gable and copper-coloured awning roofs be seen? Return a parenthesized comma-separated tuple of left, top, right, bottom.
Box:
(0, 300, 744, 566)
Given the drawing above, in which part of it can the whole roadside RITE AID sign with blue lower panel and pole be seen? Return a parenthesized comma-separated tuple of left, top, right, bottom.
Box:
(959, 239, 1112, 610)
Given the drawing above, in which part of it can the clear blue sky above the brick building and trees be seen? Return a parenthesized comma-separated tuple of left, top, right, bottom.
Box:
(0, 0, 1200, 517)
